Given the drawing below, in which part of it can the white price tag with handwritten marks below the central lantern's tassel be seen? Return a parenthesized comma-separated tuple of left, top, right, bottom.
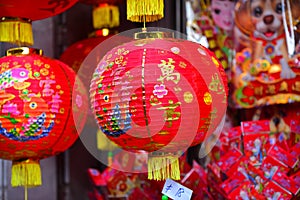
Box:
(161, 179, 193, 200)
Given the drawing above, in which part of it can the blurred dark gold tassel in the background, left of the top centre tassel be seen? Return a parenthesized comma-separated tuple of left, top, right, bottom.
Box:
(93, 4, 120, 29)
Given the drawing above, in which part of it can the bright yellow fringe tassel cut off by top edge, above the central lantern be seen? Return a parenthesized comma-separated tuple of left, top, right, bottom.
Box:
(127, 0, 164, 22)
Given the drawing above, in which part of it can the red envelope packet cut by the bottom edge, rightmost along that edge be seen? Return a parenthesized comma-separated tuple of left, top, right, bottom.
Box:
(262, 181, 292, 200)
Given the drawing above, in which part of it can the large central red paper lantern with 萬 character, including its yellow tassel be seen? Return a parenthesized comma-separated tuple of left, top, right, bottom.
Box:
(90, 33, 227, 180)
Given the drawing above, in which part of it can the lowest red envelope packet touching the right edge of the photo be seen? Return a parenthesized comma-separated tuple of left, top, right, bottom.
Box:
(273, 172, 300, 195)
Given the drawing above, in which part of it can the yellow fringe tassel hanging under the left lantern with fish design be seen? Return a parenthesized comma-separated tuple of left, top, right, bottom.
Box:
(11, 159, 42, 187)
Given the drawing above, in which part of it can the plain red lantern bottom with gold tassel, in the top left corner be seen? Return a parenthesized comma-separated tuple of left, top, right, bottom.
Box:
(0, 0, 78, 45)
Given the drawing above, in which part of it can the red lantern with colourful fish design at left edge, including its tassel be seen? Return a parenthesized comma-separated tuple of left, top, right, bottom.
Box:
(0, 47, 87, 187)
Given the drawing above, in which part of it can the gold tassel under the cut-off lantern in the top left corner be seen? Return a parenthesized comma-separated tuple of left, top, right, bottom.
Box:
(0, 17, 33, 46)
